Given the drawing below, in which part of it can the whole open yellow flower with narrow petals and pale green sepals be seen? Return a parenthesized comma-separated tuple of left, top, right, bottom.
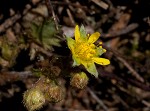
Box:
(67, 25, 110, 77)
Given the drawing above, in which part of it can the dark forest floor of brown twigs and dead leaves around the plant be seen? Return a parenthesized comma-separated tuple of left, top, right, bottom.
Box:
(0, 0, 150, 111)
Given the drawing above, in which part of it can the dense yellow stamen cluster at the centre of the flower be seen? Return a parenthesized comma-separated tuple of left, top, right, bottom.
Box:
(74, 42, 96, 61)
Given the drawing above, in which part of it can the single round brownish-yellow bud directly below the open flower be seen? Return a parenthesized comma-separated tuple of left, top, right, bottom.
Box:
(70, 72, 89, 89)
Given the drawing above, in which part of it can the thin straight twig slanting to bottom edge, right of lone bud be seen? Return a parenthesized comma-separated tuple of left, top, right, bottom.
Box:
(87, 87, 108, 111)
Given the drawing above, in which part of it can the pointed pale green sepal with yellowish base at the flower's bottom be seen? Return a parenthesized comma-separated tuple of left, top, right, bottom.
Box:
(82, 61, 98, 78)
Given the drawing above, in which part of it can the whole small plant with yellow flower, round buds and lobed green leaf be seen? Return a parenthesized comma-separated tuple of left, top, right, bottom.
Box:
(23, 21, 110, 111)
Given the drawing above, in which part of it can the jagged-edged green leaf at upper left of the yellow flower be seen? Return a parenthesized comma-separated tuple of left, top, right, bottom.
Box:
(31, 19, 61, 50)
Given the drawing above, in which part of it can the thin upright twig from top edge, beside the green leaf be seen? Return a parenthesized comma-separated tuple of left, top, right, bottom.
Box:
(45, 0, 59, 30)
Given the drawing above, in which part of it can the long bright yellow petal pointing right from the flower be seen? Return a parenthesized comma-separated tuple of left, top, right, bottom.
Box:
(92, 57, 110, 65)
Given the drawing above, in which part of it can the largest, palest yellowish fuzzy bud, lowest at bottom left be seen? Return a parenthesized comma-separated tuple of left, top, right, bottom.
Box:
(23, 87, 45, 111)
